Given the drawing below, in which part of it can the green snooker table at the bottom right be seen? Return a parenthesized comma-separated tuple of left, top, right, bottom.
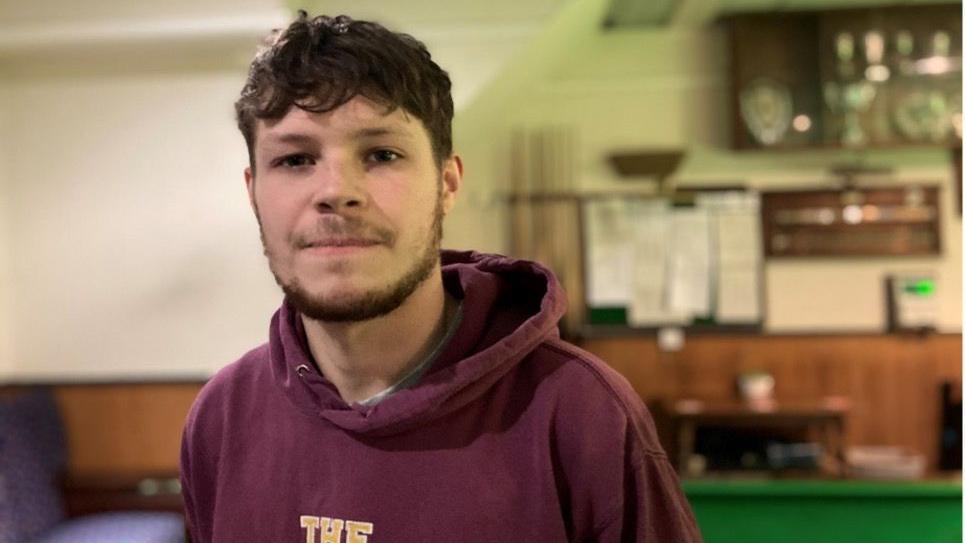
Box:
(683, 479, 962, 543)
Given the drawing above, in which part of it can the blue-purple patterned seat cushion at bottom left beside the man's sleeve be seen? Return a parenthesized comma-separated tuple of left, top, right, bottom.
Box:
(30, 512, 184, 543)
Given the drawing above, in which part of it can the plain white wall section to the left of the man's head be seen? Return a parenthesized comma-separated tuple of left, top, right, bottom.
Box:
(0, 72, 279, 379)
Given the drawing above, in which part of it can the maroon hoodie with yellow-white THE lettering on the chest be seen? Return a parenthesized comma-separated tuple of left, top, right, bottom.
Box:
(181, 251, 700, 543)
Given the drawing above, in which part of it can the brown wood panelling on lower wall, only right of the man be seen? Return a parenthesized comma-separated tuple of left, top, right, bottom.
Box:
(581, 334, 962, 466)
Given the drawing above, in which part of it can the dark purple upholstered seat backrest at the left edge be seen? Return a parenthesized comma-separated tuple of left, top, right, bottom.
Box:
(0, 389, 66, 543)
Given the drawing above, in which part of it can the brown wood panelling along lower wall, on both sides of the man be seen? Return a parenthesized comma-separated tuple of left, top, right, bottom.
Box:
(5, 334, 962, 474)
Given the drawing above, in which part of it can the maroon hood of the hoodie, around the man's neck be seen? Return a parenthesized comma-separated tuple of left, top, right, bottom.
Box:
(268, 250, 566, 435)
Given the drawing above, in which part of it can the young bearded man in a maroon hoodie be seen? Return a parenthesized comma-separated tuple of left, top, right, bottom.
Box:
(182, 13, 700, 543)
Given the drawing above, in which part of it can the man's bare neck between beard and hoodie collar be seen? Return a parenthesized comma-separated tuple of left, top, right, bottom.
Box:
(301, 268, 456, 404)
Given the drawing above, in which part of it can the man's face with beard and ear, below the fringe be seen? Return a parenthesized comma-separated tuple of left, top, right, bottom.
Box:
(245, 96, 462, 321)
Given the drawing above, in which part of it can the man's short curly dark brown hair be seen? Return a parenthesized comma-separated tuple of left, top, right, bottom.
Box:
(235, 10, 453, 170)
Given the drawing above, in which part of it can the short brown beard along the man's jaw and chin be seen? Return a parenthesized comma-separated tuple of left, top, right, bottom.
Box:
(255, 191, 444, 322)
